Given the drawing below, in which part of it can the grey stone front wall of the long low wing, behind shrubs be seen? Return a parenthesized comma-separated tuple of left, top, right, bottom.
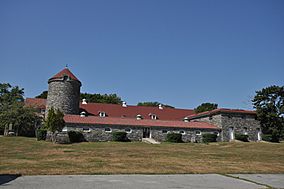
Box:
(67, 124, 220, 142)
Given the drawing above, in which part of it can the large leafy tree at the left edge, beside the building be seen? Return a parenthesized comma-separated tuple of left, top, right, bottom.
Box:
(0, 83, 40, 136)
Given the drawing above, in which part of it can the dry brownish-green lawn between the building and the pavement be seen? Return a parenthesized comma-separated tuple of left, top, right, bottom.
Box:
(0, 137, 284, 175)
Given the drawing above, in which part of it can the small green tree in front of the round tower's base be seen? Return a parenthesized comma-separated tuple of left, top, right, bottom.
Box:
(44, 107, 65, 134)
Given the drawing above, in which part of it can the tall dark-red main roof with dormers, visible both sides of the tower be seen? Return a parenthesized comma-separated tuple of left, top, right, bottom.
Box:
(25, 98, 193, 120)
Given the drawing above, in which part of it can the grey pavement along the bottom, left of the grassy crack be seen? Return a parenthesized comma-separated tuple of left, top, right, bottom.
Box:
(0, 174, 274, 189)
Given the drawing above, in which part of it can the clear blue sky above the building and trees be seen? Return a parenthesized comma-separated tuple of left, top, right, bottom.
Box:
(0, 0, 284, 109)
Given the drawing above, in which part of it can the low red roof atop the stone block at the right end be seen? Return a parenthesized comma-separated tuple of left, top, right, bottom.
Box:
(187, 108, 256, 118)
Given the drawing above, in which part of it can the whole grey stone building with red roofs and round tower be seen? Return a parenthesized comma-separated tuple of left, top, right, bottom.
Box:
(26, 68, 261, 142)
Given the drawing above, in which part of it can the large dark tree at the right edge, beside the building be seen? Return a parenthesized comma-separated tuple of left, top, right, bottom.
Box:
(252, 85, 284, 142)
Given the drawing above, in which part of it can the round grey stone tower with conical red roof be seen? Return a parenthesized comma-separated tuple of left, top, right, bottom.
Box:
(46, 67, 81, 114)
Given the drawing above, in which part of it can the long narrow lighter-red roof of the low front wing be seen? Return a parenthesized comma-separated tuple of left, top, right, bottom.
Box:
(64, 115, 219, 129)
